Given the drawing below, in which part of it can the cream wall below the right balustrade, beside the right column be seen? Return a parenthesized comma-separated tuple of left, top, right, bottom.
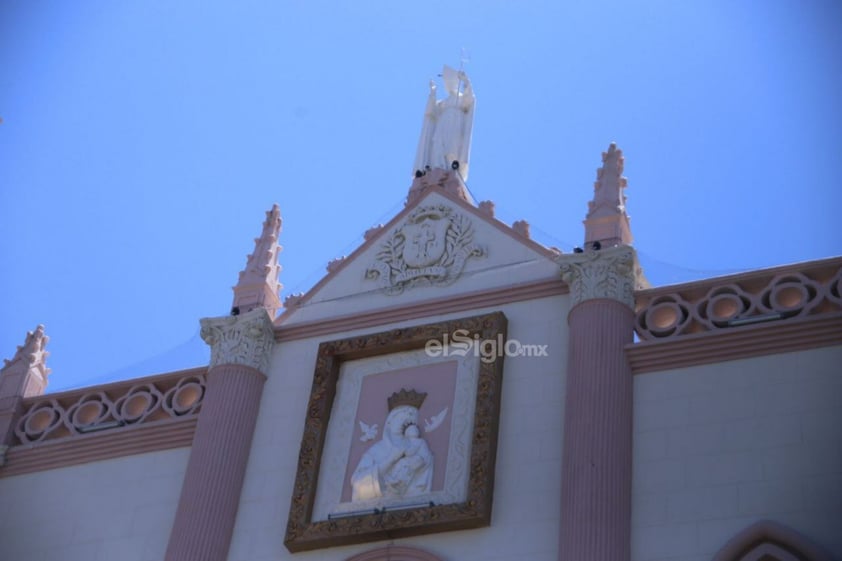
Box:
(632, 347, 842, 561)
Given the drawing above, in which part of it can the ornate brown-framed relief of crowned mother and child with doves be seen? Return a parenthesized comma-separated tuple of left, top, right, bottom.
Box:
(284, 312, 506, 552)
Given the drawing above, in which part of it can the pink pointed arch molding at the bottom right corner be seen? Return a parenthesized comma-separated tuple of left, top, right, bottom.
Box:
(712, 520, 832, 561)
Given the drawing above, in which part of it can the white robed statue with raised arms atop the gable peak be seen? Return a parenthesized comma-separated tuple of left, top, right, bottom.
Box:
(414, 66, 476, 180)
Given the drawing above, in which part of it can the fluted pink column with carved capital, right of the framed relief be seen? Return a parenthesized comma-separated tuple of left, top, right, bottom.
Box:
(559, 247, 635, 561)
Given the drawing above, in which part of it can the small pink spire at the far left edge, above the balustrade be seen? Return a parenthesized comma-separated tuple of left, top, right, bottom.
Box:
(0, 325, 50, 400)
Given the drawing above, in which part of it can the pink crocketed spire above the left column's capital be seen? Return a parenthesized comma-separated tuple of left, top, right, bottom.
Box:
(231, 205, 282, 318)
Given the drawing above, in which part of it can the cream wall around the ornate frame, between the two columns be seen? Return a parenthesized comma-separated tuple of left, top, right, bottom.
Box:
(229, 296, 568, 561)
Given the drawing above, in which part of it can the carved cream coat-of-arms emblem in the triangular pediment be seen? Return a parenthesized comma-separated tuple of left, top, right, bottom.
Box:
(366, 205, 486, 294)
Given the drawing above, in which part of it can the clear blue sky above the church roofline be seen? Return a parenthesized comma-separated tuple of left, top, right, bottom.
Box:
(0, 0, 842, 391)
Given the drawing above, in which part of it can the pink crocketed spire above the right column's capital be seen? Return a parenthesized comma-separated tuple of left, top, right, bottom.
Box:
(584, 142, 632, 249)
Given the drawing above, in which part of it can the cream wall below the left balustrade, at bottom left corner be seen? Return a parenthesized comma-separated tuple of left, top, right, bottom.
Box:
(0, 448, 190, 561)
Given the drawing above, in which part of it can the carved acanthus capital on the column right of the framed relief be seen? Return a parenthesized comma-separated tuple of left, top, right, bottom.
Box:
(558, 245, 646, 309)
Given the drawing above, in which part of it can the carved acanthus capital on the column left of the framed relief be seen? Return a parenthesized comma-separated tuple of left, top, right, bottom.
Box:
(200, 308, 275, 374)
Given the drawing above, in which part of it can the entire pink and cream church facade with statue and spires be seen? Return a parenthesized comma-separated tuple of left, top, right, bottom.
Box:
(0, 71, 842, 561)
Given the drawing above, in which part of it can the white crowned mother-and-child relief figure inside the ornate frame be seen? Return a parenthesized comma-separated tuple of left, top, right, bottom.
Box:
(351, 390, 433, 502)
